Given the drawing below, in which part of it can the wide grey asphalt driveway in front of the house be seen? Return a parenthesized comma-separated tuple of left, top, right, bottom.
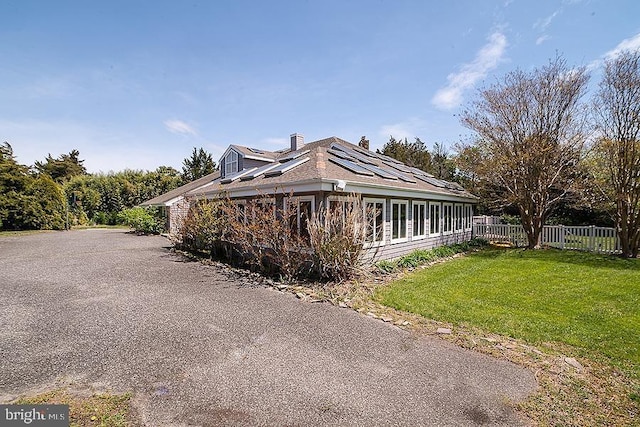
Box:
(0, 230, 535, 426)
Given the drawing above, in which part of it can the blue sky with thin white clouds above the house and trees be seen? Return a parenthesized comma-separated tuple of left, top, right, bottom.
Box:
(0, 0, 640, 172)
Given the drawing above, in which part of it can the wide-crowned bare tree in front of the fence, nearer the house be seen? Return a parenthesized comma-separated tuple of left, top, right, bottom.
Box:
(461, 57, 589, 249)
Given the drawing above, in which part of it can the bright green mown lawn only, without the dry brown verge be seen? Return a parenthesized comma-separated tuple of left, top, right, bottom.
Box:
(376, 249, 640, 378)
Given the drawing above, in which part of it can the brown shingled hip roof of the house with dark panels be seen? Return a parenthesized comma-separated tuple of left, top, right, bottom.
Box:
(188, 136, 477, 202)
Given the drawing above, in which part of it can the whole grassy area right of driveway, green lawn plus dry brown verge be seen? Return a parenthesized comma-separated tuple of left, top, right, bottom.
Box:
(374, 249, 640, 426)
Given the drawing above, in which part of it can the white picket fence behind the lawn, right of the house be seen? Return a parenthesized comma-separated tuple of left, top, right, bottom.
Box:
(473, 223, 620, 254)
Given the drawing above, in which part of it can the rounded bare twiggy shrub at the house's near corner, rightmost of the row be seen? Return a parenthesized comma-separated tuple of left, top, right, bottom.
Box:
(308, 196, 366, 281)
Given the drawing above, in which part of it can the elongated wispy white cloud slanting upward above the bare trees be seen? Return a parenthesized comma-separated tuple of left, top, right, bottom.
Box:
(431, 32, 507, 110)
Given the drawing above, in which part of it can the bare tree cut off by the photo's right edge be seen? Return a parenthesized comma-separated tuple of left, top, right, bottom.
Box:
(594, 50, 640, 257)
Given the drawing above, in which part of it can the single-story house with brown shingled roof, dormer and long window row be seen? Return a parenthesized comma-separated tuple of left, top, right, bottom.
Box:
(144, 134, 478, 259)
